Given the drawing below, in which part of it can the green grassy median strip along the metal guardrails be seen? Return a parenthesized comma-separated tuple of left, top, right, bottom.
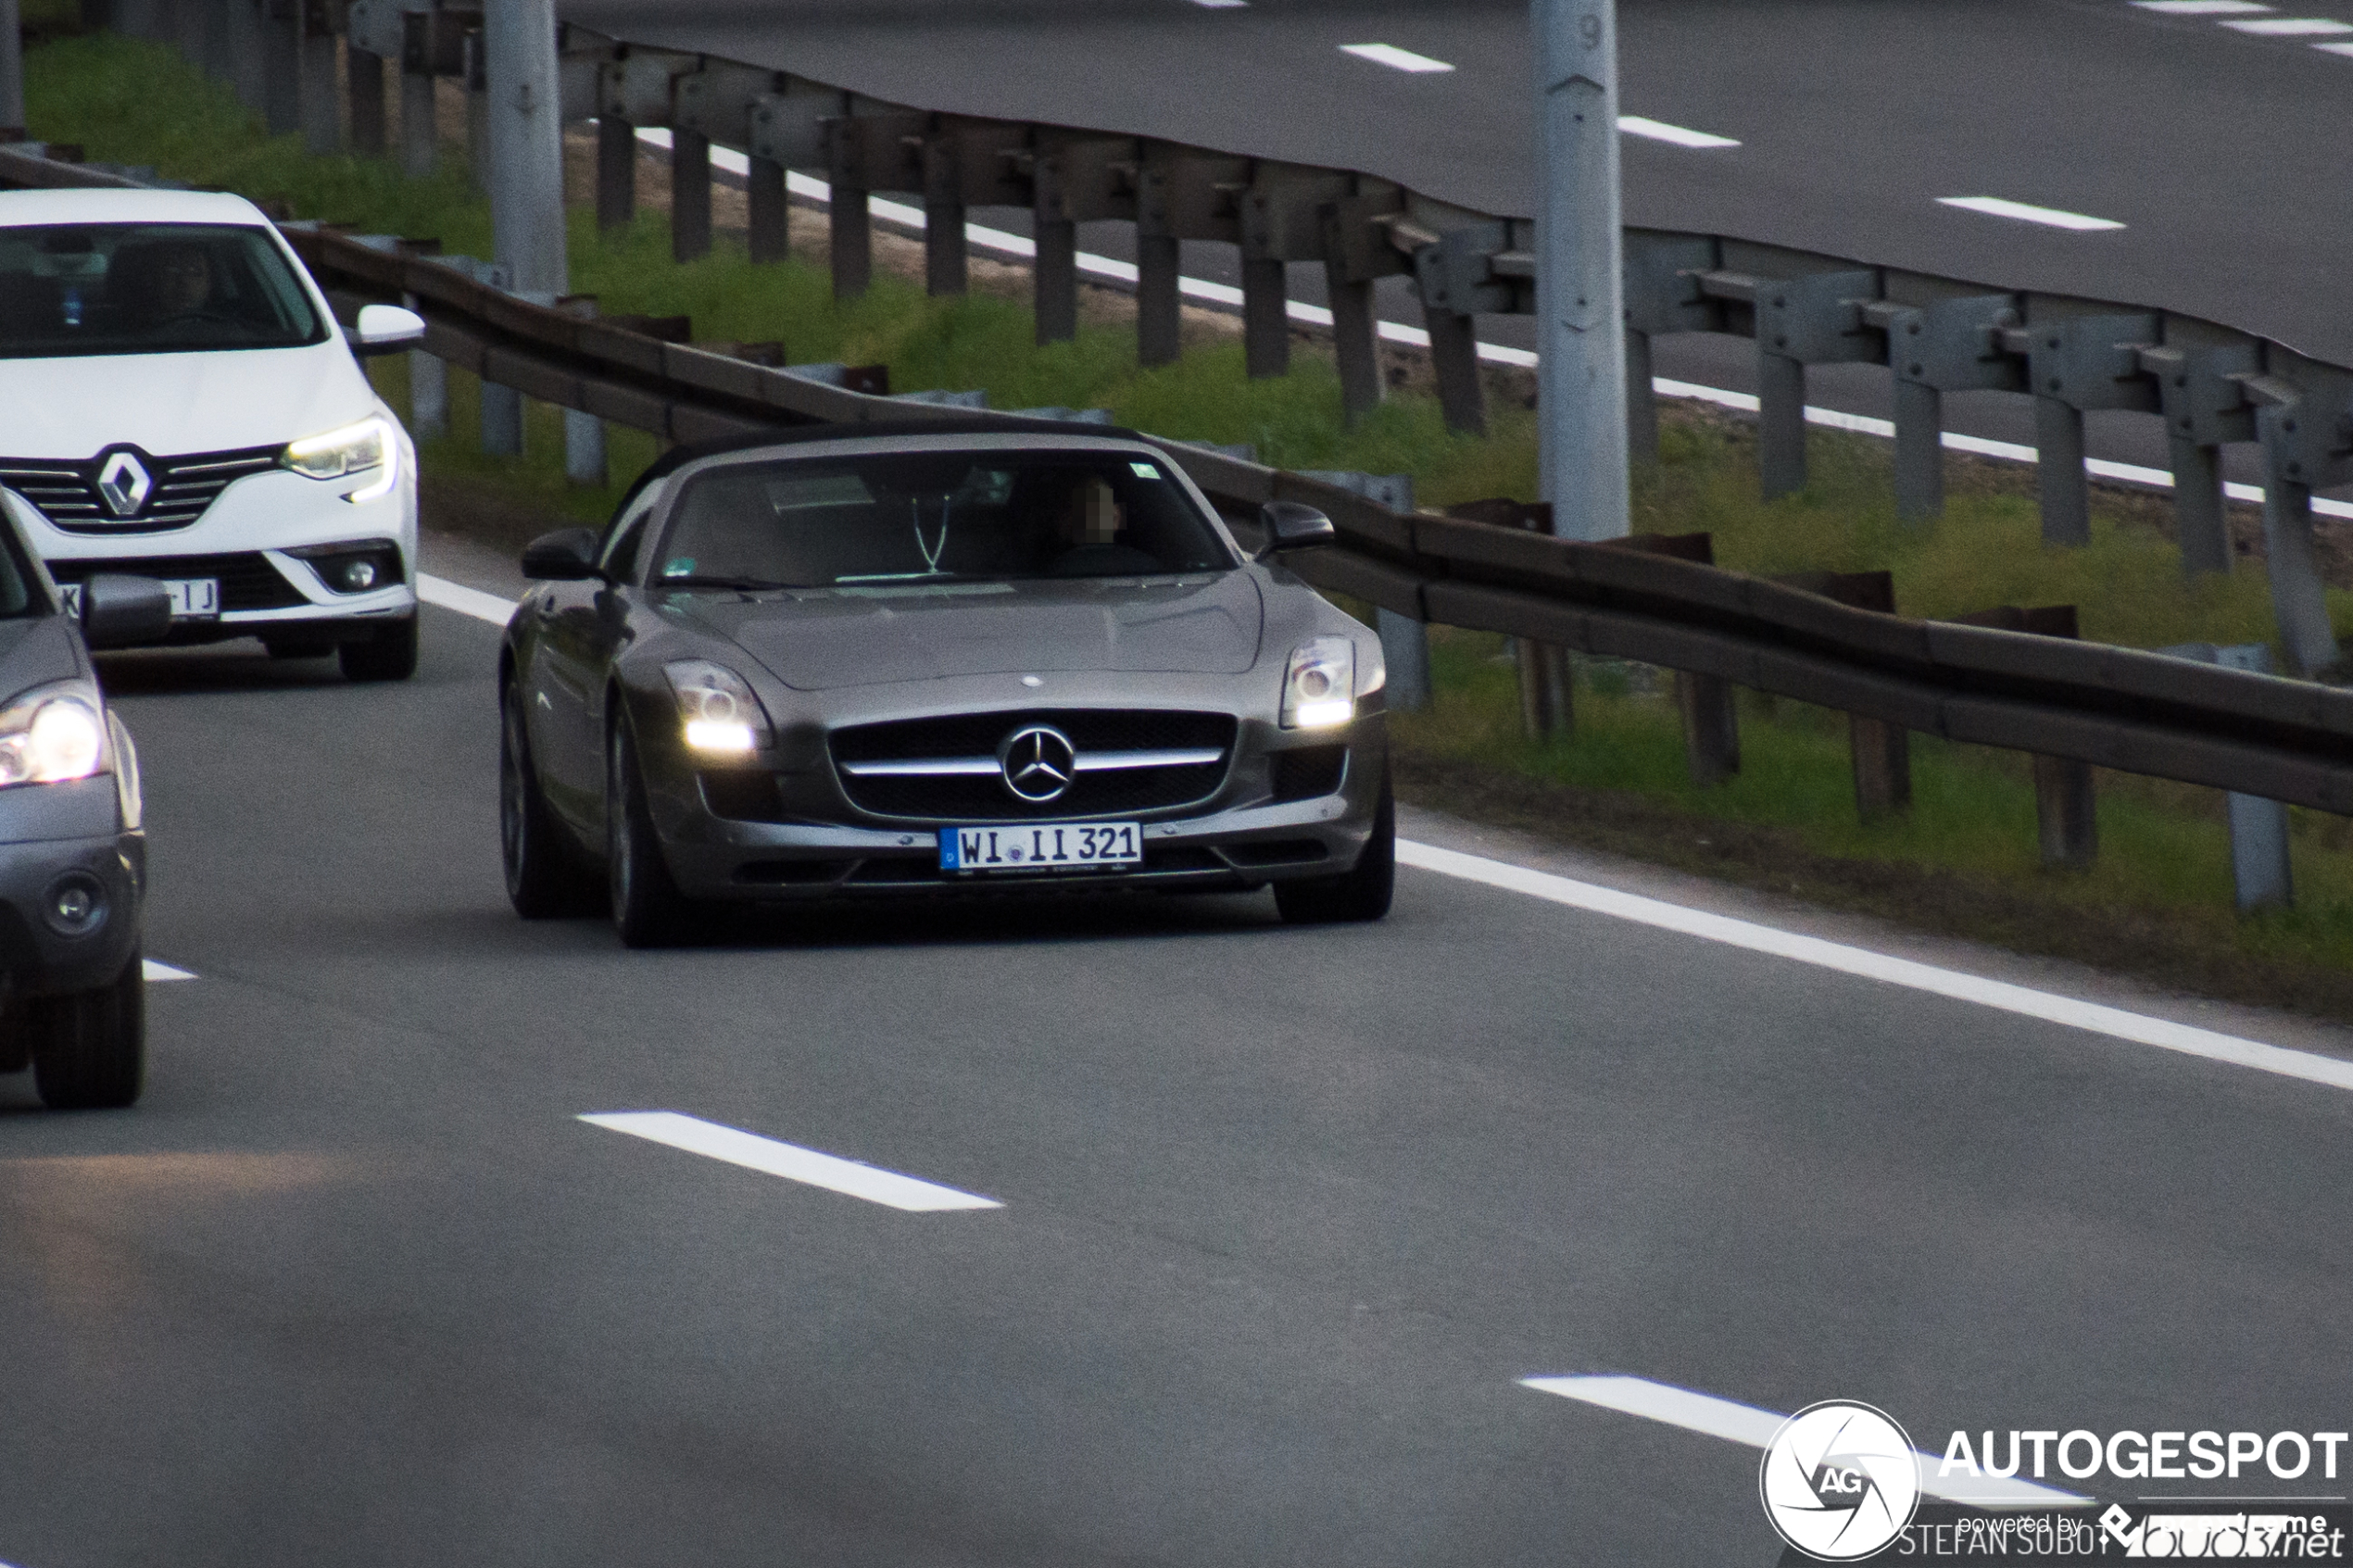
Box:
(26, 38, 2353, 1016)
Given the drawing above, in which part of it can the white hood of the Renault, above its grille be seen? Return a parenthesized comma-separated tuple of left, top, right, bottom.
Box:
(0, 344, 376, 458)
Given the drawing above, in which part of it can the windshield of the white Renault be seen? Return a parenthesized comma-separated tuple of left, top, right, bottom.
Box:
(0, 223, 327, 359)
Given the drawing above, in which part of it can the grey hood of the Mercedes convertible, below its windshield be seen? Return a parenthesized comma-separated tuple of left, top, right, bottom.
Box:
(689, 571, 1266, 691)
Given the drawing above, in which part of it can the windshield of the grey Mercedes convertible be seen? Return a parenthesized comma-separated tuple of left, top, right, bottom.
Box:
(652, 451, 1233, 588)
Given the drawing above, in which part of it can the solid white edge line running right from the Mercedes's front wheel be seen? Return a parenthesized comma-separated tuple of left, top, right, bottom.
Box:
(1398, 839, 2353, 1088)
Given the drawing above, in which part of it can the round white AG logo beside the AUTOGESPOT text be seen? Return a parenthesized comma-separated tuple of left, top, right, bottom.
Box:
(1757, 1399, 1920, 1563)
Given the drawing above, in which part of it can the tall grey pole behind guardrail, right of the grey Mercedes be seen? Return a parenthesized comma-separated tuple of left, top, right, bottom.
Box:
(1529, 0, 1630, 538)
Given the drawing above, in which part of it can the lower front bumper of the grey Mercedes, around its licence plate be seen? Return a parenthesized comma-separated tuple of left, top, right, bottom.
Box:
(640, 712, 1389, 903)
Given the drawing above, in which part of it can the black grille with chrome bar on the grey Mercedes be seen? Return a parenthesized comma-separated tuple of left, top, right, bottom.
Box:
(833, 708, 1238, 822)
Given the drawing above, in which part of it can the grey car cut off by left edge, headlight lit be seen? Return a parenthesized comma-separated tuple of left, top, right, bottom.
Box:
(0, 501, 171, 1110)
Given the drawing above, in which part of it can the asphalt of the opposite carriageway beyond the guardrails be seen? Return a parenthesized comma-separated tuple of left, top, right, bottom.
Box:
(560, 0, 2353, 482)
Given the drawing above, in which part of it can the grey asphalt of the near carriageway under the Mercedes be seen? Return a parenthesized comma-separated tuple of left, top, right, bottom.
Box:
(13, 555, 2353, 1568)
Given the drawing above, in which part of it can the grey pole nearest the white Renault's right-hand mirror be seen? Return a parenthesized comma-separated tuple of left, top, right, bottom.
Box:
(483, 0, 572, 294)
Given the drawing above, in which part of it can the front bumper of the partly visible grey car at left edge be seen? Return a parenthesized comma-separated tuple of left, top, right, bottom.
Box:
(0, 773, 145, 999)
